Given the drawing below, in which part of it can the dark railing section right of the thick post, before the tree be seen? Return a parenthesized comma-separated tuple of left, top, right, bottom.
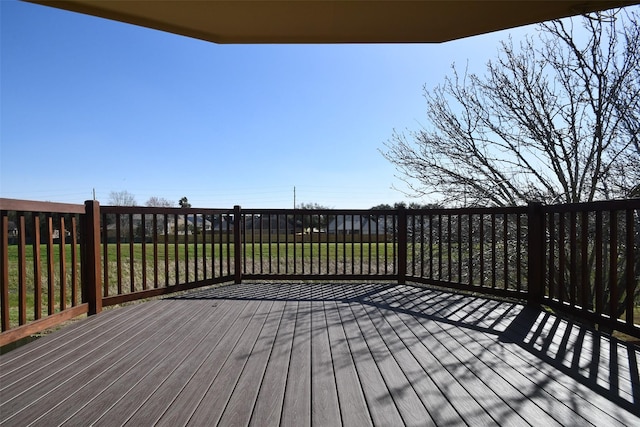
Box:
(538, 199, 640, 336)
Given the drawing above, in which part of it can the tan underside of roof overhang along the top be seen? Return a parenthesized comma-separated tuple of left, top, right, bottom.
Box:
(27, 0, 640, 43)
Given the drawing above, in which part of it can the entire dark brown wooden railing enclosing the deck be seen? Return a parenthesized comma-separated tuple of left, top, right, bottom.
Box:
(0, 199, 640, 345)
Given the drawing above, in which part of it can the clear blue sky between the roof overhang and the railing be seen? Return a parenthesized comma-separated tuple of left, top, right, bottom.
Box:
(0, 0, 534, 208)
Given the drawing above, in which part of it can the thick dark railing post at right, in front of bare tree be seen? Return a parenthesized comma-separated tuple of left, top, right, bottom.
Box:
(527, 202, 545, 305)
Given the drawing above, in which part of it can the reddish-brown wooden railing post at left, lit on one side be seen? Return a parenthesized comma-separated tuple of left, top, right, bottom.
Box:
(80, 200, 102, 315)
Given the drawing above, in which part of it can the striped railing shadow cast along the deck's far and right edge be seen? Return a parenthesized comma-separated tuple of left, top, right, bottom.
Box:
(172, 283, 640, 416)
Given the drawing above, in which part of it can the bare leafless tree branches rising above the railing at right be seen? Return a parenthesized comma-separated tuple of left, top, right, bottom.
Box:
(382, 9, 640, 206)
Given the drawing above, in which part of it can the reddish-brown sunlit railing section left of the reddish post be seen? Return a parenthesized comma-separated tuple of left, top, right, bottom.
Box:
(0, 199, 90, 345)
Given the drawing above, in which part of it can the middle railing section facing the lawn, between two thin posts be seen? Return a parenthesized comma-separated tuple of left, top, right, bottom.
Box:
(238, 209, 399, 280)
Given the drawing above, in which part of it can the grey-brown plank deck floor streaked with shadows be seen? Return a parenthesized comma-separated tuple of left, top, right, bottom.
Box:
(0, 284, 640, 427)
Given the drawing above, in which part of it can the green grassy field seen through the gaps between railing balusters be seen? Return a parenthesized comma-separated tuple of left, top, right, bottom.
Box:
(2, 242, 640, 332)
